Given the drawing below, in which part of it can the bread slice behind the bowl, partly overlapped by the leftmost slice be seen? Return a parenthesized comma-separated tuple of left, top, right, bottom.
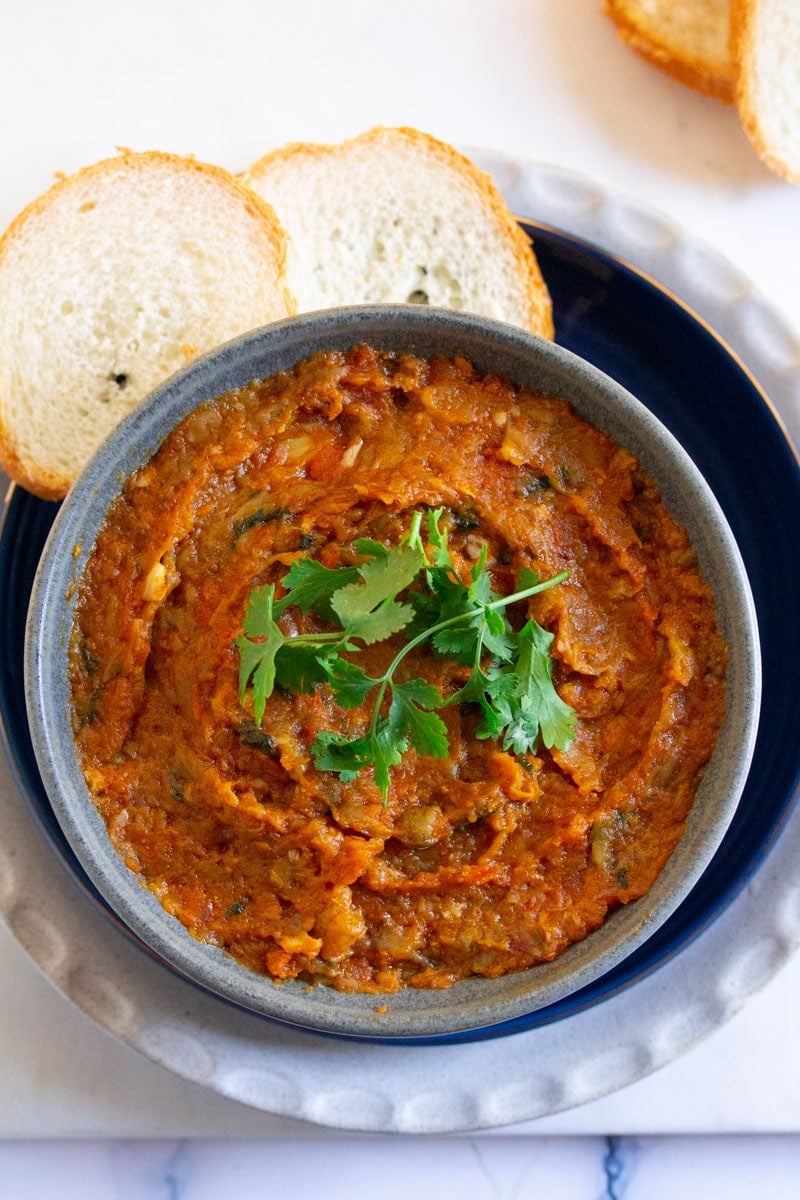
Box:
(243, 128, 553, 337)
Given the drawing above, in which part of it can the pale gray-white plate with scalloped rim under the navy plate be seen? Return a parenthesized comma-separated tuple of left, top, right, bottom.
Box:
(0, 151, 800, 1133)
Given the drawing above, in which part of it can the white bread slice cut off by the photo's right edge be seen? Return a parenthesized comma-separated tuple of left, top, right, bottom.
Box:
(730, 0, 800, 184)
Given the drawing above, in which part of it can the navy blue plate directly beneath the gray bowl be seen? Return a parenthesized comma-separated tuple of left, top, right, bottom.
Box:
(0, 224, 800, 1044)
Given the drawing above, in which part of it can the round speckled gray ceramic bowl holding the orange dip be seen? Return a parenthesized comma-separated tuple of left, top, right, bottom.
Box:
(26, 306, 760, 1038)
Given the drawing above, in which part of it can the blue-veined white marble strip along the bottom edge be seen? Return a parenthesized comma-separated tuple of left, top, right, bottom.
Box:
(0, 1135, 799, 1200)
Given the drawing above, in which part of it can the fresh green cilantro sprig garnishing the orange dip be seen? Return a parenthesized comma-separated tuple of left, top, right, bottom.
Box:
(236, 509, 576, 803)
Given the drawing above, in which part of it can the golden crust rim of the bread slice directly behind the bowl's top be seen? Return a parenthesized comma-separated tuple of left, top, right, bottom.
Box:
(247, 125, 554, 338)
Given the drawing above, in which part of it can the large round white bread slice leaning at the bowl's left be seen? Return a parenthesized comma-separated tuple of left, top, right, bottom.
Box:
(0, 151, 295, 499)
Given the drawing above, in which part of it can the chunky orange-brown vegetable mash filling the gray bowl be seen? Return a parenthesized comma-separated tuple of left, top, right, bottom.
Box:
(70, 347, 726, 992)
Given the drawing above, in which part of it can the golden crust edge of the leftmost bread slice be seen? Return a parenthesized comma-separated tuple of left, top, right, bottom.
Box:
(0, 149, 296, 500)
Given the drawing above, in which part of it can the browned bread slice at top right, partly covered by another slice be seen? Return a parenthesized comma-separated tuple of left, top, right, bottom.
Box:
(606, 0, 733, 103)
